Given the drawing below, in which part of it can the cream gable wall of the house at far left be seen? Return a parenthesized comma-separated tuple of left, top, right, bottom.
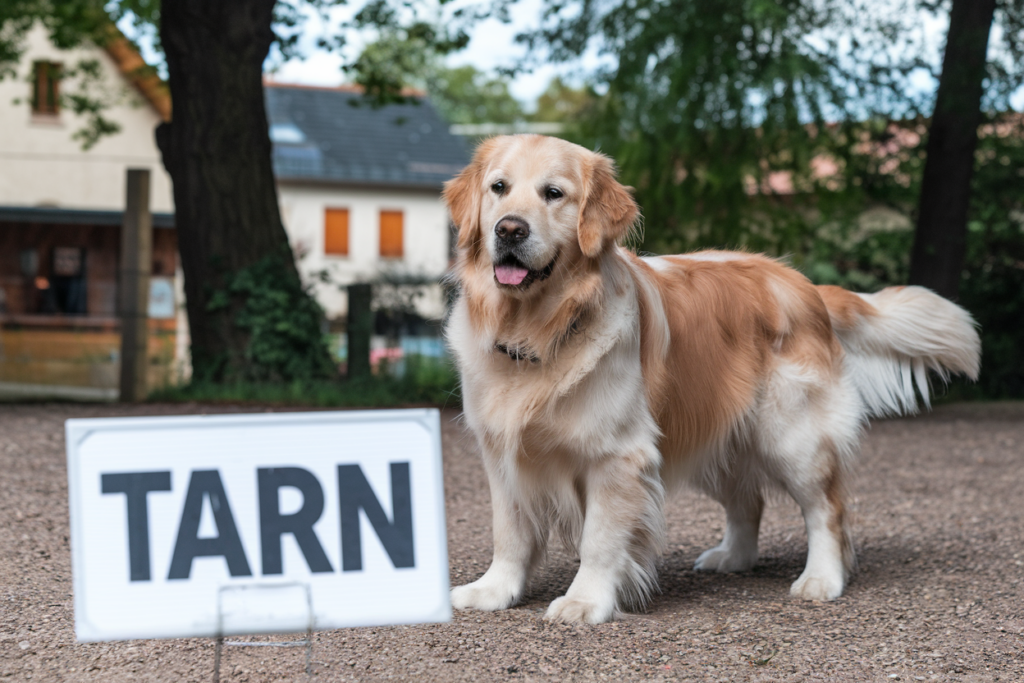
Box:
(0, 25, 174, 212)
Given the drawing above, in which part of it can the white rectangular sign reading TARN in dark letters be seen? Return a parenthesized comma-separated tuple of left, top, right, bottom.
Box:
(66, 410, 452, 641)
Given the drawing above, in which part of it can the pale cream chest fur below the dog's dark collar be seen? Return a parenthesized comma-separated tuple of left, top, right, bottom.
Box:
(447, 278, 656, 459)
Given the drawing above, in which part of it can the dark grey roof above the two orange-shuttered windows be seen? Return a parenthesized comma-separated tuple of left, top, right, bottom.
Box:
(264, 85, 469, 189)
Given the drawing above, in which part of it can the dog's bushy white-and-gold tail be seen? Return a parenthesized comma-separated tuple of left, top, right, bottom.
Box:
(818, 287, 981, 417)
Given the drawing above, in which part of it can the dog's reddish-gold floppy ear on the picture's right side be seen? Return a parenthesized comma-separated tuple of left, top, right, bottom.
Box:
(577, 153, 640, 258)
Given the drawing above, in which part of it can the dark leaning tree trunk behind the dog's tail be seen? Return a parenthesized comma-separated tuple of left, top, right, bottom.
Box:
(910, 0, 995, 299)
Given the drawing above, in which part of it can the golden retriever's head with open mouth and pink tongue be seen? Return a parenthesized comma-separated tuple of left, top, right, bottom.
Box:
(444, 135, 638, 293)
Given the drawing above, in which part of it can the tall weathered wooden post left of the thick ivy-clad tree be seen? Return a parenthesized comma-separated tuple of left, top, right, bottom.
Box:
(118, 168, 153, 401)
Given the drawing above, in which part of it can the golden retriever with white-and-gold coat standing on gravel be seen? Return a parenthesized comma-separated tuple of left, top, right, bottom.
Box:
(444, 135, 980, 624)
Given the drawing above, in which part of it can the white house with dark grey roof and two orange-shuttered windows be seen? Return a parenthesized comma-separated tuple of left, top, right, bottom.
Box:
(265, 83, 468, 319)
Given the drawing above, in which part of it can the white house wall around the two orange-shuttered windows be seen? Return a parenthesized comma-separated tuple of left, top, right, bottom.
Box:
(278, 182, 450, 318)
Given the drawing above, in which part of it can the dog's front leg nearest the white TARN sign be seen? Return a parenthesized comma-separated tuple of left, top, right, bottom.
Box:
(452, 457, 547, 611)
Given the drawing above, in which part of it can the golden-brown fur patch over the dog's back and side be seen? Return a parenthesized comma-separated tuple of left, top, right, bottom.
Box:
(628, 253, 842, 464)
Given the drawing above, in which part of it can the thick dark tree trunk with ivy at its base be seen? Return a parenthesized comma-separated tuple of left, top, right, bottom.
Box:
(157, 0, 331, 381)
